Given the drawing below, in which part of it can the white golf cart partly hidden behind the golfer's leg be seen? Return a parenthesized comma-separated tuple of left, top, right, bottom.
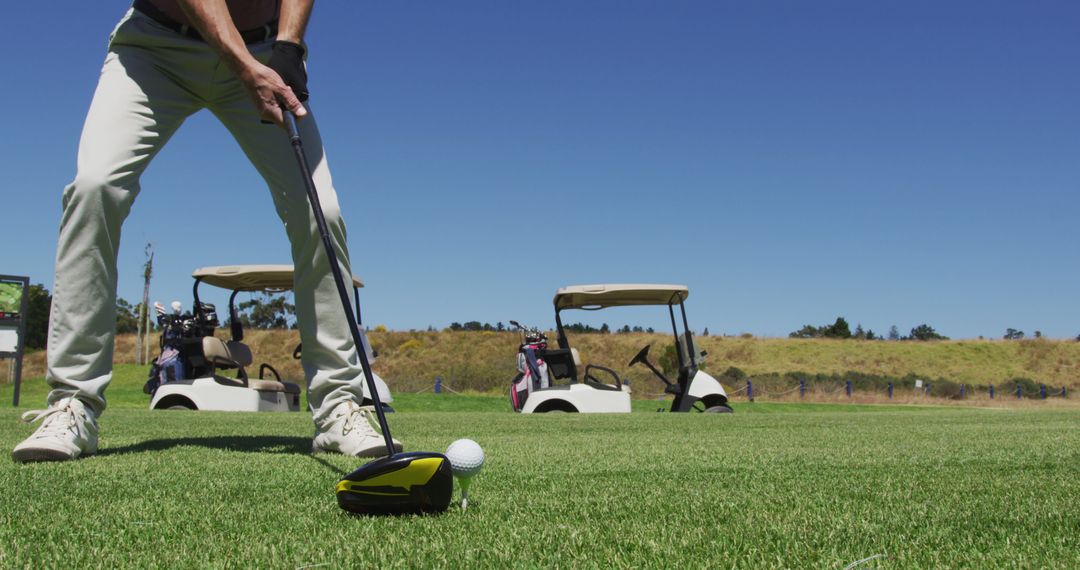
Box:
(144, 264, 392, 411)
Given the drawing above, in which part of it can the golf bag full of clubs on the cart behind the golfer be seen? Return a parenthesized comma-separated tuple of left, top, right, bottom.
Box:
(143, 301, 218, 395)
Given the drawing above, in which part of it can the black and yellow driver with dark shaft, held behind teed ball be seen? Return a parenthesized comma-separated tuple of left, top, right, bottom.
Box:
(282, 108, 454, 515)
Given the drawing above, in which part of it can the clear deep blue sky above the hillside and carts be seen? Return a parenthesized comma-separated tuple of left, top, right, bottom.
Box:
(0, 0, 1080, 338)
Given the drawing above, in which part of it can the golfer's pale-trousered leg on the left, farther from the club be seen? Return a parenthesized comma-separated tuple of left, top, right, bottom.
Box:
(46, 12, 197, 415)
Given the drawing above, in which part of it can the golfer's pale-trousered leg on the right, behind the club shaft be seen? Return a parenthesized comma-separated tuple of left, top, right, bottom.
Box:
(211, 96, 366, 421)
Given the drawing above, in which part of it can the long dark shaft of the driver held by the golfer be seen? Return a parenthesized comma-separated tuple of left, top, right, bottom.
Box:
(282, 108, 394, 456)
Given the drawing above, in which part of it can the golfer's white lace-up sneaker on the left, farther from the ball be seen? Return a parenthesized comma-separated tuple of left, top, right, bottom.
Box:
(11, 397, 97, 462)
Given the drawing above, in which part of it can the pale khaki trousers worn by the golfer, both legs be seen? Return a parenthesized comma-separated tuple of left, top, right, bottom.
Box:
(46, 10, 366, 421)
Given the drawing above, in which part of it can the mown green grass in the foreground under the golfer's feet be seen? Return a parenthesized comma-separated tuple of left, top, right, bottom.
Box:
(0, 394, 1080, 569)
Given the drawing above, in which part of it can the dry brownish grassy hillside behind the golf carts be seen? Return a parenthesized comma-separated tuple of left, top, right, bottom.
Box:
(10, 330, 1080, 395)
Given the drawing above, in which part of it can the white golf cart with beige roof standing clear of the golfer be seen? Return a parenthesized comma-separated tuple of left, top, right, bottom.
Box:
(518, 285, 732, 413)
